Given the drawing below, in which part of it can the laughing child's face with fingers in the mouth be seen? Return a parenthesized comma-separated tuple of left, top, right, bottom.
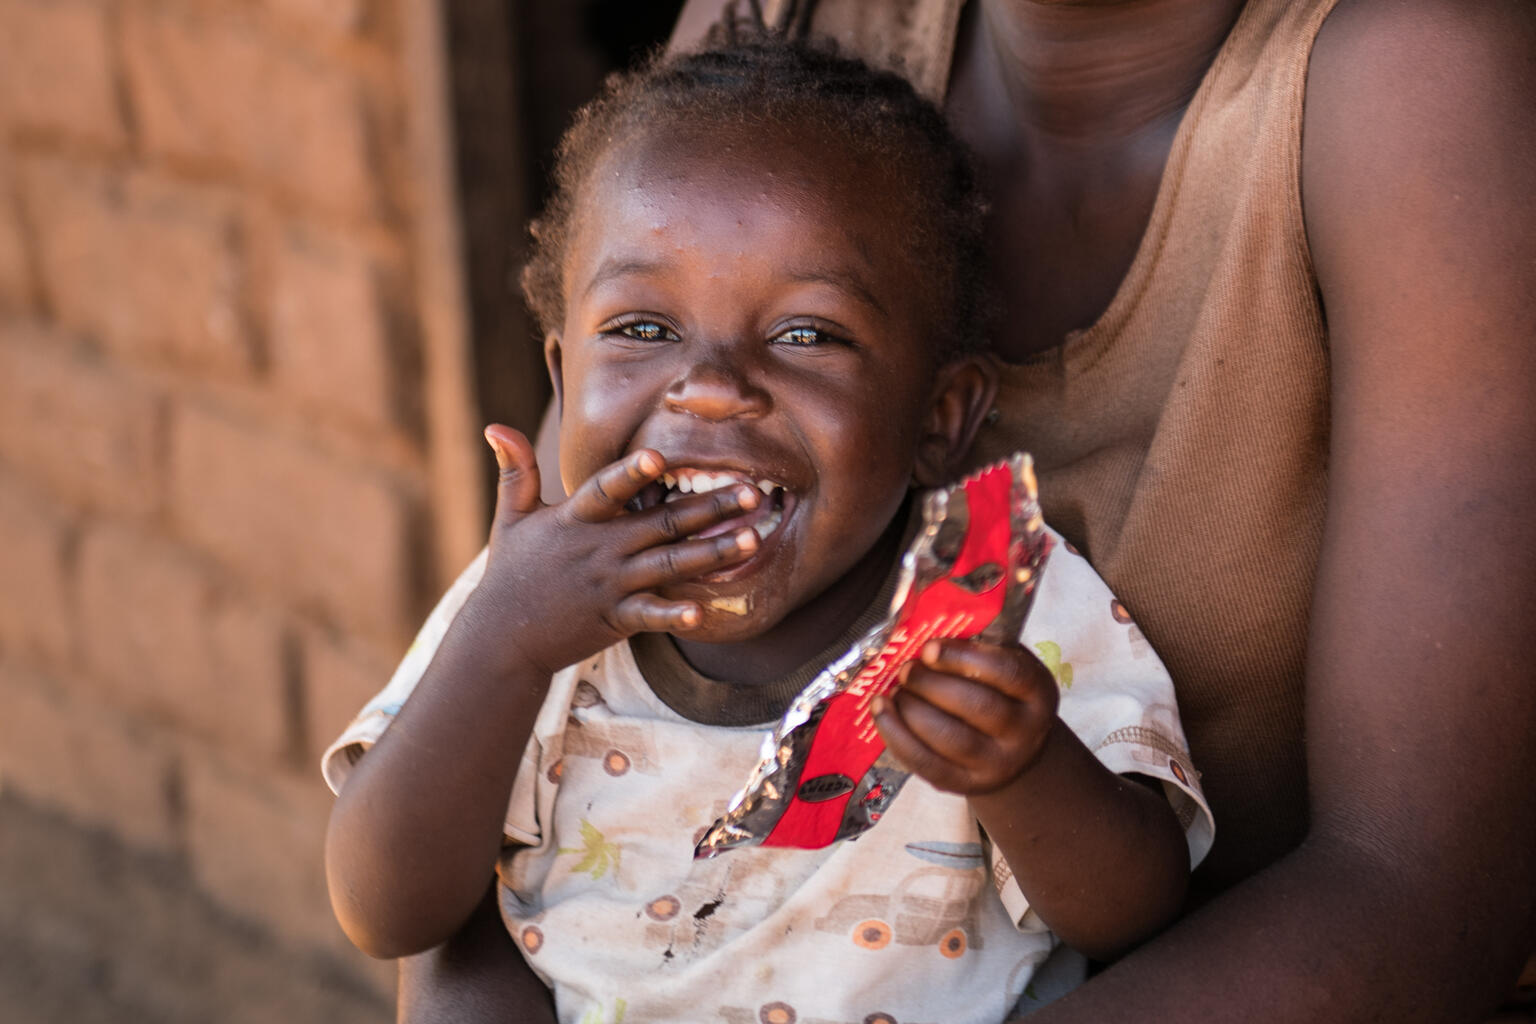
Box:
(548, 125, 974, 642)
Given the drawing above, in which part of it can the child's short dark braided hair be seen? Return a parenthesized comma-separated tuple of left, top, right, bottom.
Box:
(522, 18, 986, 359)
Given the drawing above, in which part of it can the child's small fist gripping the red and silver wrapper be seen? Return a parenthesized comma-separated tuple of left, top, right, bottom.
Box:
(871, 640, 1060, 797)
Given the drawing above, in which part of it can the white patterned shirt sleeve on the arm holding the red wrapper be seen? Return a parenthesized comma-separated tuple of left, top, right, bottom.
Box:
(991, 531, 1215, 927)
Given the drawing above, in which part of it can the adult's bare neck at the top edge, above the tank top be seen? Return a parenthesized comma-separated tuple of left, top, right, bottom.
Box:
(958, 0, 1244, 149)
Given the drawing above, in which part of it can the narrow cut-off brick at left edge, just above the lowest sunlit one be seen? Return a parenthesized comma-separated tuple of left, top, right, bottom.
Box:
(0, 476, 75, 665)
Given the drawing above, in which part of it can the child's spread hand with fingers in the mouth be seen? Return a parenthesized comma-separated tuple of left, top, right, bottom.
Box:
(472, 425, 762, 674)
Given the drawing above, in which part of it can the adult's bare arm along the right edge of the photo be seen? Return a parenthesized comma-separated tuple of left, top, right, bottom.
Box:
(1007, 0, 1536, 1024)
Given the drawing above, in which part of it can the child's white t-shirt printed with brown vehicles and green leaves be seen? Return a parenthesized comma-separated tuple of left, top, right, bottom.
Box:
(324, 539, 1213, 1024)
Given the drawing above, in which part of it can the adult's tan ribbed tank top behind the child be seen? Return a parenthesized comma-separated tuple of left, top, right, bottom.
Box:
(765, 0, 1335, 894)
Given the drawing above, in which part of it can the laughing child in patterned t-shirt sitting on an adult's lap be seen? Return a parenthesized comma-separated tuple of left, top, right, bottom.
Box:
(326, 32, 1210, 1022)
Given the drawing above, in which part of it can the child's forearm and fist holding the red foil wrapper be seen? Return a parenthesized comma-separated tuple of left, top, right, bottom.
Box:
(874, 640, 1189, 960)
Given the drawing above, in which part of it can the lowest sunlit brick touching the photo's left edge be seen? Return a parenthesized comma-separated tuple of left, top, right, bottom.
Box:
(0, 660, 178, 851)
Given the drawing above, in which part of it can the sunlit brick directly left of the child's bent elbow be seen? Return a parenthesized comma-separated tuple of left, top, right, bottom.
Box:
(186, 752, 346, 949)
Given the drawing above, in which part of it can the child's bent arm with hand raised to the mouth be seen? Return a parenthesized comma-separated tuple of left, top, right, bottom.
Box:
(326, 427, 760, 956)
